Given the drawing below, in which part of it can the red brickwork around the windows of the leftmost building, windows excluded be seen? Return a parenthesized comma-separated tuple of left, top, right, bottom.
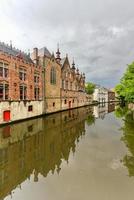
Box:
(0, 52, 42, 100)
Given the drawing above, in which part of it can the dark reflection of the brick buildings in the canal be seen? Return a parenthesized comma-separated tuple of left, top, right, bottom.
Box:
(0, 107, 93, 199)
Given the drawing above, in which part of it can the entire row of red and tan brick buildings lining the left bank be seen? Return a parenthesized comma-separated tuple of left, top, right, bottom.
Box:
(0, 43, 89, 124)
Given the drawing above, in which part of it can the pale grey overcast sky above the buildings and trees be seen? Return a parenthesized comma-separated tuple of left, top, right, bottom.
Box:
(0, 0, 134, 88)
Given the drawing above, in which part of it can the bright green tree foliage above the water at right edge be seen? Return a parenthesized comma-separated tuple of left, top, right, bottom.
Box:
(115, 62, 134, 102)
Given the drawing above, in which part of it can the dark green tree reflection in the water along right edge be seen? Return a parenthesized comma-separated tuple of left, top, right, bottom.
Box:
(115, 106, 134, 177)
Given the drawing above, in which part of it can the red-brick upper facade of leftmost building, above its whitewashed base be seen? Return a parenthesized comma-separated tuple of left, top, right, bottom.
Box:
(0, 47, 42, 101)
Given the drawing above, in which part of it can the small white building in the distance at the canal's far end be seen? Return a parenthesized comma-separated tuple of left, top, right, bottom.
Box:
(93, 85, 108, 103)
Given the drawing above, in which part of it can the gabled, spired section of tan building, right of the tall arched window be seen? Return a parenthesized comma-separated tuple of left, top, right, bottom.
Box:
(61, 52, 86, 109)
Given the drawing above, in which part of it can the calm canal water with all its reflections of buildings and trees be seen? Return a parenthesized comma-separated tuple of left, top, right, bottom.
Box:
(0, 104, 134, 200)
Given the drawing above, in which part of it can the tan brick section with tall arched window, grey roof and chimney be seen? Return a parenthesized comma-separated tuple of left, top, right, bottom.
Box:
(31, 47, 61, 113)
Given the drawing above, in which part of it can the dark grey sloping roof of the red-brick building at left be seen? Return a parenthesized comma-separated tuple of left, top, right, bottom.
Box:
(0, 42, 33, 63)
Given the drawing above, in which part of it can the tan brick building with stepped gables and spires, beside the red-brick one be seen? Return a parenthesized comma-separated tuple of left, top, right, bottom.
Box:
(31, 47, 87, 113)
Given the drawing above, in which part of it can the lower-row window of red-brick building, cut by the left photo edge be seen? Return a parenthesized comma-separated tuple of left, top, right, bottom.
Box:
(0, 83, 9, 100)
